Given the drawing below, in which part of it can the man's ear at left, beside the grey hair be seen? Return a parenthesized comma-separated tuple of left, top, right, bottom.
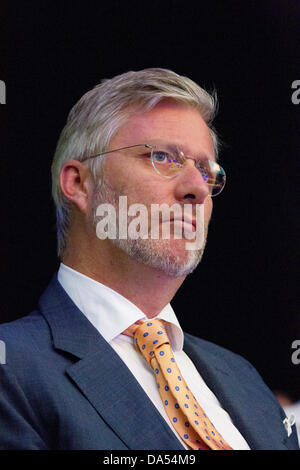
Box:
(59, 160, 91, 213)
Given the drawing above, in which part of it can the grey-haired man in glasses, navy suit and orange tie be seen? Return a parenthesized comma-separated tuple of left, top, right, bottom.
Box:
(0, 69, 298, 450)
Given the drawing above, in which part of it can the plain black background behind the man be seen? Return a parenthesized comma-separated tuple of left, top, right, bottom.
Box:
(0, 0, 300, 399)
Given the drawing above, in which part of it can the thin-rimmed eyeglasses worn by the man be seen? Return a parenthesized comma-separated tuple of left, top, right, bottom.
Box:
(81, 144, 226, 197)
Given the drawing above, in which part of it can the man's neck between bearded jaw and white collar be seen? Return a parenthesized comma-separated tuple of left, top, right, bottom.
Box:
(62, 235, 185, 318)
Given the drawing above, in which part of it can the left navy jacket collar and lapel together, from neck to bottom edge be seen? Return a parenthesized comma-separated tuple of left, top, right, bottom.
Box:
(40, 277, 183, 450)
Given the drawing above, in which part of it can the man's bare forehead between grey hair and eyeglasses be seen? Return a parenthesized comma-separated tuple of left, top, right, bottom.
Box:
(110, 101, 214, 158)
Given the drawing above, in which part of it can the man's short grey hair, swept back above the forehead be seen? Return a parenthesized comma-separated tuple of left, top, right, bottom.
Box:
(51, 68, 218, 257)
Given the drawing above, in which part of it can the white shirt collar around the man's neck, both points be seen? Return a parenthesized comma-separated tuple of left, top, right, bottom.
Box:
(57, 263, 183, 351)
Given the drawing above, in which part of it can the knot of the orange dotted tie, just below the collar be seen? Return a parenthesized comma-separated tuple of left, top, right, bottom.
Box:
(126, 320, 170, 364)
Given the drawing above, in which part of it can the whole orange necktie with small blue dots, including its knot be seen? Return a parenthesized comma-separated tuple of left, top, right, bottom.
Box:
(123, 320, 232, 450)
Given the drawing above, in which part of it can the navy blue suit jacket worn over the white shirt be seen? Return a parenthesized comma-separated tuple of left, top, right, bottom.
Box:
(0, 276, 298, 450)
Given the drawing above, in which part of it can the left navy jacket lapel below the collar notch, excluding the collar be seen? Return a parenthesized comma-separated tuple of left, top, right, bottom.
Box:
(67, 345, 182, 450)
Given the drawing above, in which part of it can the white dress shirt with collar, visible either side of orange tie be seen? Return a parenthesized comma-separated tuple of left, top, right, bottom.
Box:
(58, 263, 249, 450)
